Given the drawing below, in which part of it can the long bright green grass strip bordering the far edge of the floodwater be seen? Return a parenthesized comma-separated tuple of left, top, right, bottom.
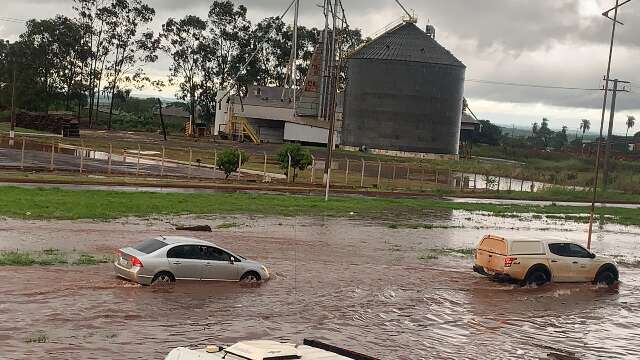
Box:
(0, 186, 640, 225)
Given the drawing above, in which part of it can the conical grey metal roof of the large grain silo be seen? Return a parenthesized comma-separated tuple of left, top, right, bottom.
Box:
(349, 22, 465, 67)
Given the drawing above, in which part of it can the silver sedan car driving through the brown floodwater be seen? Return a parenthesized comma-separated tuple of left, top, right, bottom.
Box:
(113, 236, 270, 285)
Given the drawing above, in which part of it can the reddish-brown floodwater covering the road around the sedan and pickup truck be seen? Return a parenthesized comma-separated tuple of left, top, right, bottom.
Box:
(0, 210, 640, 359)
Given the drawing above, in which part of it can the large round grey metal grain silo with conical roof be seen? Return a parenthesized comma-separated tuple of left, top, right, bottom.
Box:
(341, 22, 466, 158)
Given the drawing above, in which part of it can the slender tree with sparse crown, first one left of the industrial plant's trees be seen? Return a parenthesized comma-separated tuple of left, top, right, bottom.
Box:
(161, 15, 208, 133)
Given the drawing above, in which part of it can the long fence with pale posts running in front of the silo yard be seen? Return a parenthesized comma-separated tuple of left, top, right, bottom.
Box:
(0, 132, 600, 192)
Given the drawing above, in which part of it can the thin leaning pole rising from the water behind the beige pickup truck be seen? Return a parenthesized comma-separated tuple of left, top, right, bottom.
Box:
(587, 0, 631, 250)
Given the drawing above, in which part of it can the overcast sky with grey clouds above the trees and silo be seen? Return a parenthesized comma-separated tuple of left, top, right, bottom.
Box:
(0, 0, 640, 133)
